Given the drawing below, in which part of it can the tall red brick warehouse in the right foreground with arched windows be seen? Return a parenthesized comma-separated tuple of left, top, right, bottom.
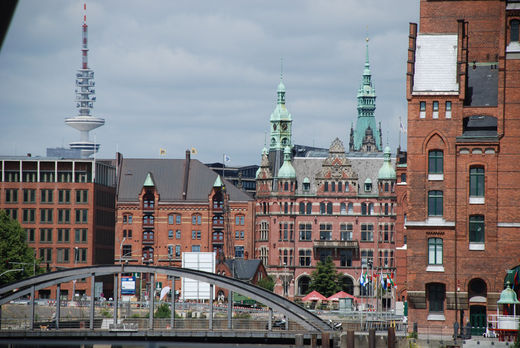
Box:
(404, 0, 520, 333)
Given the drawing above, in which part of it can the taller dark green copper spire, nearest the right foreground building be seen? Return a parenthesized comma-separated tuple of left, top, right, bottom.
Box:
(350, 38, 382, 151)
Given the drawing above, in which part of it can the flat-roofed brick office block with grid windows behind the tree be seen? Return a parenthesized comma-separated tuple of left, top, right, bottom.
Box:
(0, 157, 116, 299)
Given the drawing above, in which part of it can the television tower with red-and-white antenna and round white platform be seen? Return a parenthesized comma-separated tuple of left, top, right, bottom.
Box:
(65, 3, 105, 158)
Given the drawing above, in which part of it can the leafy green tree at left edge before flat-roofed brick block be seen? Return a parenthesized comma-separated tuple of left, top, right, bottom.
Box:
(0, 209, 39, 286)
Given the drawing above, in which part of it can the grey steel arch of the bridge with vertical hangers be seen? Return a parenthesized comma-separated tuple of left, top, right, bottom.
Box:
(0, 265, 332, 333)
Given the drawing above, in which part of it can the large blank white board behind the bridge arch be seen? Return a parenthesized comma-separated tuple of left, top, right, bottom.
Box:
(181, 252, 216, 300)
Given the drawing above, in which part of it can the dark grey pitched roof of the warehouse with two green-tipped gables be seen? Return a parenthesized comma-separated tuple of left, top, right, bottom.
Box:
(118, 158, 252, 202)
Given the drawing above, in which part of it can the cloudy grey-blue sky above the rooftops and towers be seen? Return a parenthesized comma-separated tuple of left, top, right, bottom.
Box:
(0, 0, 419, 166)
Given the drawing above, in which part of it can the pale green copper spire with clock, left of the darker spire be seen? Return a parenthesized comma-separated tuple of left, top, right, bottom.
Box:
(269, 64, 292, 150)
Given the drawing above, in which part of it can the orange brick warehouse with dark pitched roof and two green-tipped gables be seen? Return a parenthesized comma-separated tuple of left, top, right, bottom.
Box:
(114, 151, 254, 300)
